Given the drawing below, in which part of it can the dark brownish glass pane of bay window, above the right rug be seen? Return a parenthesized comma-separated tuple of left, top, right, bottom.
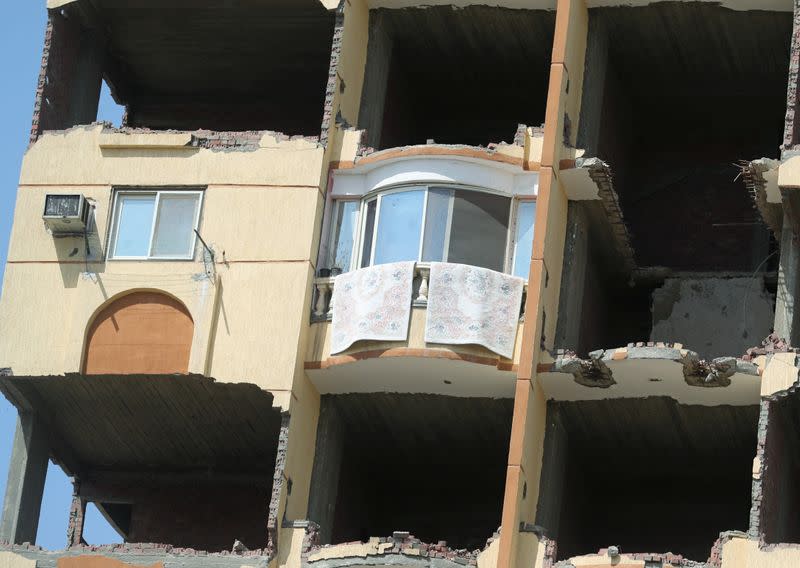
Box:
(447, 191, 511, 272)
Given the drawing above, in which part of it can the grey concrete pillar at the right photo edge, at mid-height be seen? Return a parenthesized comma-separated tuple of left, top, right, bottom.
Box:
(775, 206, 800, 345)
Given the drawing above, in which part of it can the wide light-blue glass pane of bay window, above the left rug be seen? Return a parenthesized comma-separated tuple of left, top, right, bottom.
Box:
(373, 189, 425, 264)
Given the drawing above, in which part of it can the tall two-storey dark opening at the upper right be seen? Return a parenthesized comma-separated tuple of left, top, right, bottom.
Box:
(578, 2, 792, 272)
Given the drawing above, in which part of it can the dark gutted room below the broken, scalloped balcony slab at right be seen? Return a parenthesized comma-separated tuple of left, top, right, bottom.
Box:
(536, 398, 758, 560)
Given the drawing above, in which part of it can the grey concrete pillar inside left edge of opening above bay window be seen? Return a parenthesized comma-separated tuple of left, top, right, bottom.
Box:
(358, 12, 394, 148)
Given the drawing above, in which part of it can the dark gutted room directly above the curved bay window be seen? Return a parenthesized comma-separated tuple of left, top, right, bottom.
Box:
(359, 6, 555, 149)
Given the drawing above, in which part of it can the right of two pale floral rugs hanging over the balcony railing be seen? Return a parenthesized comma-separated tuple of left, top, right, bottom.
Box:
(425, 262, 524, 359)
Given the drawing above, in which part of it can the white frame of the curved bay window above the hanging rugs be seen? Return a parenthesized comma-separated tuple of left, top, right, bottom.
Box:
(326, 183, 536, 274)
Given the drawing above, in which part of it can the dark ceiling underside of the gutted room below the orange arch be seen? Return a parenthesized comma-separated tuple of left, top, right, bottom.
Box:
(0, 375, 281, 476)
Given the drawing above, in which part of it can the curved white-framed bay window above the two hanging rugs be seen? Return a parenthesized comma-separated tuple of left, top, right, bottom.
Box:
(328, 186, 536, 278)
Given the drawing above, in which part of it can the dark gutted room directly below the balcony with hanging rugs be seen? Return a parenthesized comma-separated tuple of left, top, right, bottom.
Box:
(309, 393, 513, 550)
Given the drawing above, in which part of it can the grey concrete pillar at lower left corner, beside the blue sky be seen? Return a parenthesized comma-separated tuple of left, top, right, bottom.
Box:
(0, 413, 49, 544)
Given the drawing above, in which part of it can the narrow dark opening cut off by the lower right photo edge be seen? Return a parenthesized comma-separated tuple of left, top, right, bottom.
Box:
(760, 392, 800, 544)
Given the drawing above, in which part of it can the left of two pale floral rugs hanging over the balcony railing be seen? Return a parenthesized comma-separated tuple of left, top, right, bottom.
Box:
(331, 262, 414, 354)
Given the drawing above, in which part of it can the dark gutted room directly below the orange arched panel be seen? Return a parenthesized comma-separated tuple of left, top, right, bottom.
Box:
(0, 375, 281, 552)
